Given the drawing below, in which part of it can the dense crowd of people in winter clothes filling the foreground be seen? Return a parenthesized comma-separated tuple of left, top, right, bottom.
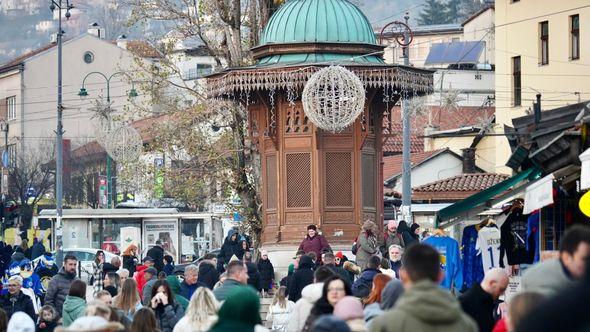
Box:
(0, 221, 590, 332)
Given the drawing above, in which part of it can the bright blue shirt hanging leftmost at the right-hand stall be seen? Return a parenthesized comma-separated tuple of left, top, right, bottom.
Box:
(424, 235, 463, 290)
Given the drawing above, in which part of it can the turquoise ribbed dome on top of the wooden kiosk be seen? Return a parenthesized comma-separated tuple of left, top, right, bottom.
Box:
(260, 0, 376, 45)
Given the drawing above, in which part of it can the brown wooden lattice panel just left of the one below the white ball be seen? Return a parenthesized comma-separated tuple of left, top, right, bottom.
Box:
(285, 153, 311, 208)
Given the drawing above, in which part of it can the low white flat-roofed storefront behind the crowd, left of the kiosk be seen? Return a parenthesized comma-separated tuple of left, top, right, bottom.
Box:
(39, 209, 223, 263)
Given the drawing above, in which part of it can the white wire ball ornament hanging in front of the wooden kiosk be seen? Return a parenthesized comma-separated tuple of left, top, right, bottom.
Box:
(301, 66, 365, 132)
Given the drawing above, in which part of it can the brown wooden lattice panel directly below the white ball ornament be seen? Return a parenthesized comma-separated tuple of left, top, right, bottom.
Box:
(324, 152, 352, 207)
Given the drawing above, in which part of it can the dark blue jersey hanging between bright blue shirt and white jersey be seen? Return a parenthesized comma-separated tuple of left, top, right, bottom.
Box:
(461, 225, 484, 288)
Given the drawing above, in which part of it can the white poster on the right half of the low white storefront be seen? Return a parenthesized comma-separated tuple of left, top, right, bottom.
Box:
(143, 220, 178, 261)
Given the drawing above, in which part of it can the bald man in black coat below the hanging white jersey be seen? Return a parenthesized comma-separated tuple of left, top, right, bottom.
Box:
(459, 268, 508, 332)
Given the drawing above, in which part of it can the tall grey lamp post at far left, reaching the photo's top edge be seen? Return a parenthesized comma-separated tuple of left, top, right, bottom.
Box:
(49, 0, 74, 223)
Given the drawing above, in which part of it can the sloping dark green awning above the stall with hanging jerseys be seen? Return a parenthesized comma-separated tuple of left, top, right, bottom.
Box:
(436, 168, 540, 228)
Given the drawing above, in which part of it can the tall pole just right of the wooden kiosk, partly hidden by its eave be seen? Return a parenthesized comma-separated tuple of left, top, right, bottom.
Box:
(402, 12, 412, 225)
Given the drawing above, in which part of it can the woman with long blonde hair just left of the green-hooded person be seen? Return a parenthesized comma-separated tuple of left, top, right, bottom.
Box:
(173, 287, 219, 332)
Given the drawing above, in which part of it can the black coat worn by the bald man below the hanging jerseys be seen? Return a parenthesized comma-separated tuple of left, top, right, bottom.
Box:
(459, 283, 496, 332)
